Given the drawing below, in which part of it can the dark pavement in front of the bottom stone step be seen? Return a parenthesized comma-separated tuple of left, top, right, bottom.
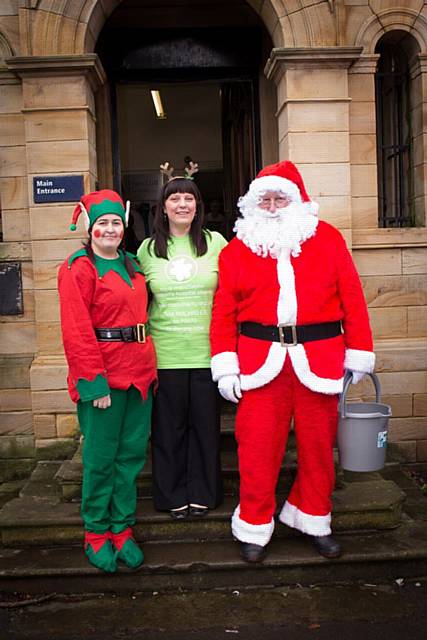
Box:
(0, 578, 427, 640)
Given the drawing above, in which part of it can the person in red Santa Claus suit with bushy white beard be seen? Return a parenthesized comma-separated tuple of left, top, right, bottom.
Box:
(211, 161, 375, 562)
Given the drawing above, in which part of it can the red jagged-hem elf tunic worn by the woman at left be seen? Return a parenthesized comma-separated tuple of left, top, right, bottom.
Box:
(58, 251, 157, 402)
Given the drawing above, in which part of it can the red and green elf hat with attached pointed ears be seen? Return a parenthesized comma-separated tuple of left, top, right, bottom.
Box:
(70, 189, 130, 231)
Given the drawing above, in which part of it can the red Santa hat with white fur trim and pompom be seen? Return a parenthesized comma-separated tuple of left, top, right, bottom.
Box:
(243, 160, 319, 215)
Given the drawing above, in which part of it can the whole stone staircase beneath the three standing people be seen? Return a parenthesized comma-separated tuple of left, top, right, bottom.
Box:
(0, 407, 427, 593)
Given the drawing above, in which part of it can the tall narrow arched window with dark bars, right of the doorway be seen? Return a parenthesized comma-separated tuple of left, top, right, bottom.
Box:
(375, 38, 415, 227)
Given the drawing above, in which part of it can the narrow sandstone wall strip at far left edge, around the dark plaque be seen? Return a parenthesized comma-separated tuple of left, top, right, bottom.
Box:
(0, 63, 36, 480)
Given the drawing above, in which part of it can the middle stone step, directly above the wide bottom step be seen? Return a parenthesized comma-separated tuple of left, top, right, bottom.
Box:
(0, 462, 405, 546)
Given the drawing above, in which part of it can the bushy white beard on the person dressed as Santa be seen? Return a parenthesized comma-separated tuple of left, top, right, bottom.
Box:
(234, 202, 319, 258)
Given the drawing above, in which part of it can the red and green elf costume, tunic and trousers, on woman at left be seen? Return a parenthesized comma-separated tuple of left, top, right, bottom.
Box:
(59, 249, 157, 536)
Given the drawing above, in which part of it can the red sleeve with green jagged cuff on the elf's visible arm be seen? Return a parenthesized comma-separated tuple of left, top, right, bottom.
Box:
(58, 258, 109, 400)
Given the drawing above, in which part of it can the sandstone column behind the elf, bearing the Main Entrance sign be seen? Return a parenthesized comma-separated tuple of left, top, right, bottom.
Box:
(8, 54, 105, 458)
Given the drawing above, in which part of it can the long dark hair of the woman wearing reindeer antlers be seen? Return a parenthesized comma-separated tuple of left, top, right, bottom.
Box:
(148, 178, 210, 260)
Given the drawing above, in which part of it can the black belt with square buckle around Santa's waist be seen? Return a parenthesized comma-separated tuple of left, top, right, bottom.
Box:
(240, 320, 342, 347)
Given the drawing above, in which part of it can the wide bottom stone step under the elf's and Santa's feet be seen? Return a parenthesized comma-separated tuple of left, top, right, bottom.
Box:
(0, 521, 427, 595)
